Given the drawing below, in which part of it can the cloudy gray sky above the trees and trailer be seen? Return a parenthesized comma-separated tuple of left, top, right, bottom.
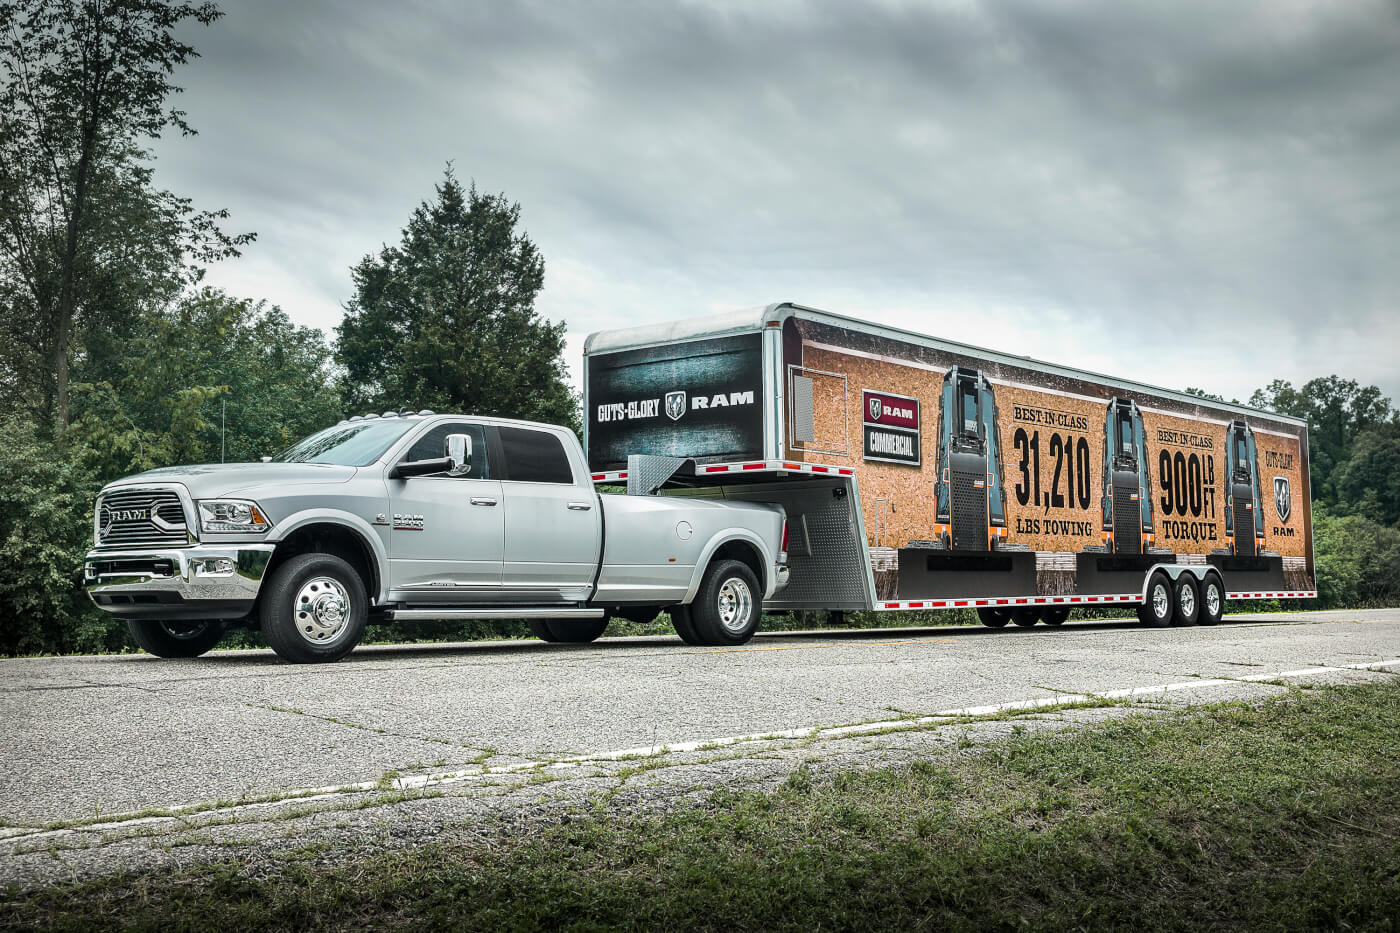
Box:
(157, 0, 1400, 398)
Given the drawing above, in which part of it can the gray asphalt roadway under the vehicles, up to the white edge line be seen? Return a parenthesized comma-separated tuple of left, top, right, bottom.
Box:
(0, 609, 1400, 825)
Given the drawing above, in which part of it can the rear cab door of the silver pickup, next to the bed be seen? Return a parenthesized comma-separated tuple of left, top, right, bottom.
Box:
(497, 424, 602, 602)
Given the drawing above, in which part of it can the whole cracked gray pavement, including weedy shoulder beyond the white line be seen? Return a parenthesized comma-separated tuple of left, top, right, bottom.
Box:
(0, 609, 1400, 884)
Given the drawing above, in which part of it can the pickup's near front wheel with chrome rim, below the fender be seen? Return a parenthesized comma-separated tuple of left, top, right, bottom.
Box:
(259, 553, 370, 664)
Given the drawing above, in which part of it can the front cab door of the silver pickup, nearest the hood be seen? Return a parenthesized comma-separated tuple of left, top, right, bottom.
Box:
(388, 422, 505, 591)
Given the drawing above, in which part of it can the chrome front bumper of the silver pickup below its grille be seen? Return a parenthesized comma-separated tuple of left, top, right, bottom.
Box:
(83, 544, 276, 621)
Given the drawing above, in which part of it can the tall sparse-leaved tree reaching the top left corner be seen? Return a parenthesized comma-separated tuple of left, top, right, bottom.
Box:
(0, 0, 251, 429)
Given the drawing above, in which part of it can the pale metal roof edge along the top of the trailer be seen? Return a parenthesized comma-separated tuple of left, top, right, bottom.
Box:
(584, 301, 1308, 426)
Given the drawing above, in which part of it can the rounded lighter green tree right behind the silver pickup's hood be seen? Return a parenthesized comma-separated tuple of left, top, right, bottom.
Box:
(74, 289, 340, 478)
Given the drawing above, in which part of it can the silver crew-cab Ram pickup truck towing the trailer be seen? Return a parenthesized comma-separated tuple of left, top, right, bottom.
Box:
(83, 412, 788, 661)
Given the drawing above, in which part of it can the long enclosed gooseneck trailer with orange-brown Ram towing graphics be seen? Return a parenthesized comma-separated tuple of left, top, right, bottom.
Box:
(584, 304, 1316, 625)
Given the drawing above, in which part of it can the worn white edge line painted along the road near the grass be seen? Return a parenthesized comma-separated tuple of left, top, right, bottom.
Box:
(13, 658, 1400, 842)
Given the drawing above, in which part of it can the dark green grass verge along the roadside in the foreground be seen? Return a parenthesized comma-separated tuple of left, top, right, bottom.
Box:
(0, 681, 1400, 930)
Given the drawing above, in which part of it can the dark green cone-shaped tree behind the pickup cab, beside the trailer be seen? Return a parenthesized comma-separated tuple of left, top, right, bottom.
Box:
(336, 167, 578, 430)
